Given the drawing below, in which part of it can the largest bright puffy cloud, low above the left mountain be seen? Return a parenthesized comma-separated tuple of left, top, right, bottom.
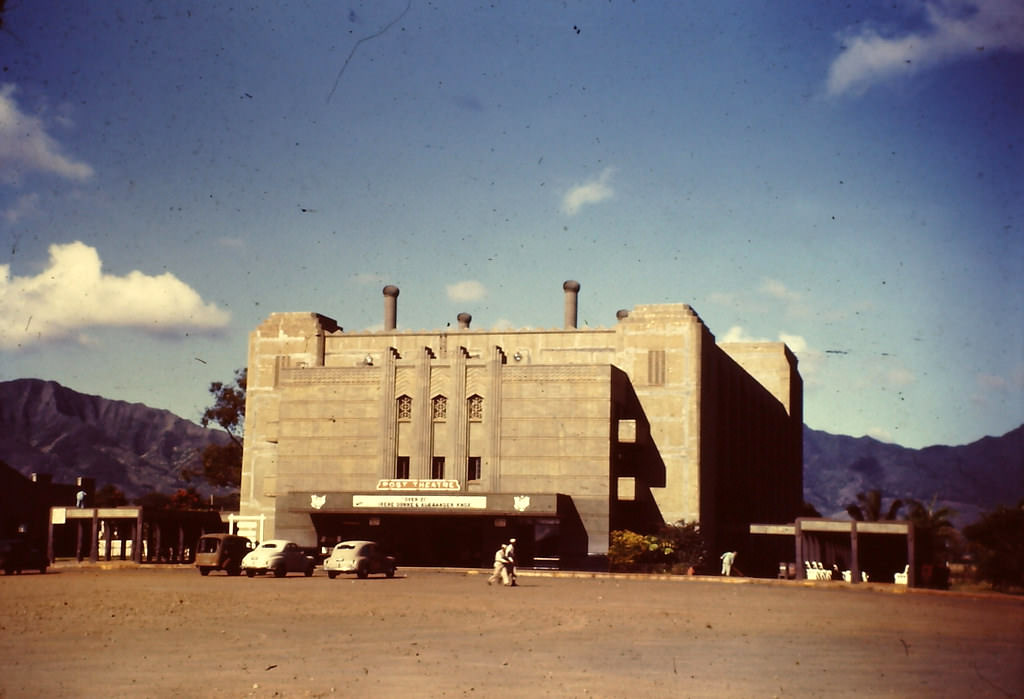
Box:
(0, 242, 230, 349)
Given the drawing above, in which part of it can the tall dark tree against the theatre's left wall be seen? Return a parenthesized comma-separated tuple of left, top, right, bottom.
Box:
(181, 368, 249, 488)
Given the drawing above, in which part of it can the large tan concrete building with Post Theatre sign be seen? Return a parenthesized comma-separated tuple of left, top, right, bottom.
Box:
(241, 281, 803, 566)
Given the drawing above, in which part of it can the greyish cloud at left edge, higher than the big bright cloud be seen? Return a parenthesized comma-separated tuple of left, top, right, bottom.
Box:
(0, 84, 92, 182)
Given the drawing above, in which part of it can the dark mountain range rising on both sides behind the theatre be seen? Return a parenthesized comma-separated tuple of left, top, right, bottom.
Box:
(0, 379, 1024, 526)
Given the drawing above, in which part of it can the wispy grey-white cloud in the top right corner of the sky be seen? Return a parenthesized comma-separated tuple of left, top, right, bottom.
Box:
(826, 0, 1024, 95)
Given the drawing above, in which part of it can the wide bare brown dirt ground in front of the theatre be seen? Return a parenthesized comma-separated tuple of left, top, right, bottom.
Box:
(0, 566, 1024, 697)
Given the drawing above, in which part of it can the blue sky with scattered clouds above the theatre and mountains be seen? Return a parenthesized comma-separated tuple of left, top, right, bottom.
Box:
(0, 0, 1024, 447)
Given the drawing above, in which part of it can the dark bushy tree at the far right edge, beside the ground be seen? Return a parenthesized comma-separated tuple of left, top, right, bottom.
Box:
(964, 500, 1024, 589)
